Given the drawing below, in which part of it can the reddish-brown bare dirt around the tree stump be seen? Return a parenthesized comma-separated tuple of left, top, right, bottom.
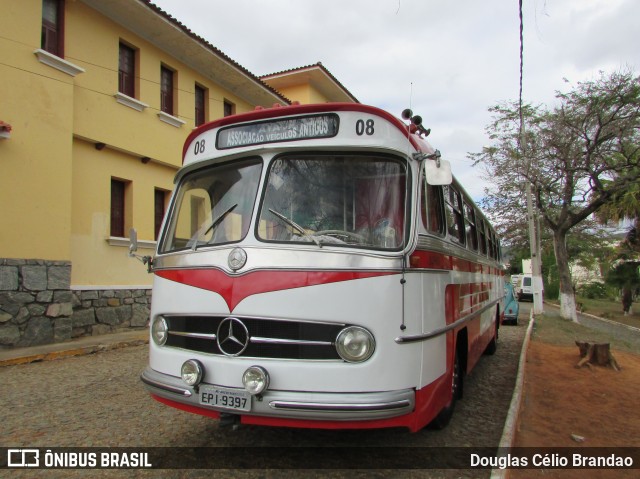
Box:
(509, 324, 640, 478)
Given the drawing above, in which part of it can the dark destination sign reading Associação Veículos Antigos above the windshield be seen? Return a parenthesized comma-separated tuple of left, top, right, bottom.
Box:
(216, 113, 340, 150)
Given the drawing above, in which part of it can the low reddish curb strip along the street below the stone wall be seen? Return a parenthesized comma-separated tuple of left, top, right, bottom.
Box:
(0, 333, 149, 367)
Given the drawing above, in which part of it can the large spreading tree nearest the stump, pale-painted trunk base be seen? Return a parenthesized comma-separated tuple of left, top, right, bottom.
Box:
(470, 72, 640, 321)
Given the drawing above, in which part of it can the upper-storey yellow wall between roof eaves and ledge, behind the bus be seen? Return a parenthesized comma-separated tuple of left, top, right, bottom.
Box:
(65, 2, 254, 168)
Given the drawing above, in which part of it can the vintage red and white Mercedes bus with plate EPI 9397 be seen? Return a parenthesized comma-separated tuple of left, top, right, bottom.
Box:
(132, 103, 504, 431)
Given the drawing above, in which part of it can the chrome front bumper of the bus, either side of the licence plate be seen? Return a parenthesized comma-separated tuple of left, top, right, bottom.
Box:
(140, 367, 415, 421)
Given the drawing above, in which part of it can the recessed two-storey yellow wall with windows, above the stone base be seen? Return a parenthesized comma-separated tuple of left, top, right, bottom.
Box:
(66, 2, 253, 289)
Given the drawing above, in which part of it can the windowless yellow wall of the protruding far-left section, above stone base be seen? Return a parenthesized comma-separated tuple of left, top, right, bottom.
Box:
(0, 0, 74, 260)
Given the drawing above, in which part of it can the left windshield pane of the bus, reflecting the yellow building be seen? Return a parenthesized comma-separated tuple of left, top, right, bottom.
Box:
(160, 159, 262, 253)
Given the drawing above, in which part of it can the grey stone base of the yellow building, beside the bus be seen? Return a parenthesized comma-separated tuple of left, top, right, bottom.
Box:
(0, 258, 151, 349)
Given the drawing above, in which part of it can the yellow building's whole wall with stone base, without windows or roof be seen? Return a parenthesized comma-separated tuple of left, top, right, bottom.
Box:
(0, 0, 276, 348)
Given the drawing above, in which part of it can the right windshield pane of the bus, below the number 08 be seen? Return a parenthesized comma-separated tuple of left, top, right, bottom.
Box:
(257, 155, 406, 250)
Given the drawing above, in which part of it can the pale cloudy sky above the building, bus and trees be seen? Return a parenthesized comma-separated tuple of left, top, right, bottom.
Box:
(152, 0, 640, 200)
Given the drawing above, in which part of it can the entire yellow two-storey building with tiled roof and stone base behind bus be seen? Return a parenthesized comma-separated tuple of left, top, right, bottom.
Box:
(0, 0, 357, 348)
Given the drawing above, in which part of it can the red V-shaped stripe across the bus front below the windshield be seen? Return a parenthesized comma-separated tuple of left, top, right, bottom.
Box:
(156, 268, 395, 312)
